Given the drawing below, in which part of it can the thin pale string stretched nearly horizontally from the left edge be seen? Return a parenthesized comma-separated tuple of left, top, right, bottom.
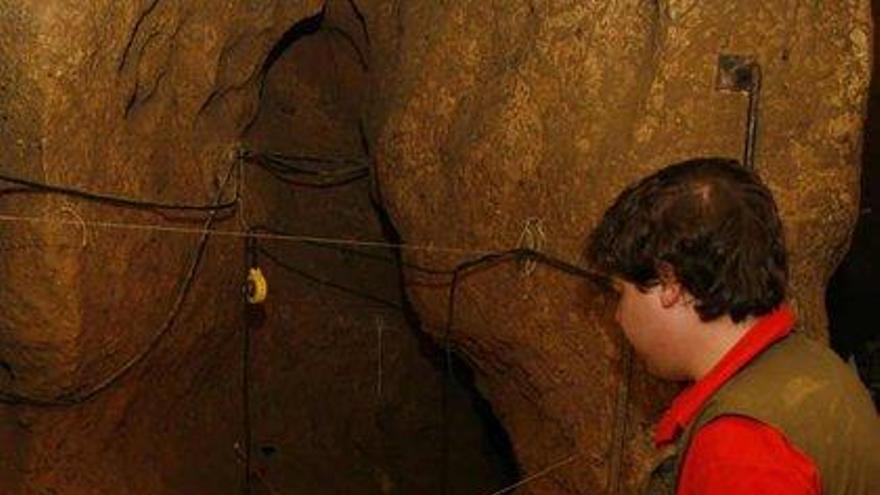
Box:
(0, 214, 495, 255)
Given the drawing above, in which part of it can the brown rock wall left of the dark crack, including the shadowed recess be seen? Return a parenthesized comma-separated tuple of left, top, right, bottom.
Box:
(0, 0, 515, 495)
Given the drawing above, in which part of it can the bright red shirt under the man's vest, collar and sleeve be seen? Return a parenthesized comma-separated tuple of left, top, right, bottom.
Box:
(654, 306, 822, 495)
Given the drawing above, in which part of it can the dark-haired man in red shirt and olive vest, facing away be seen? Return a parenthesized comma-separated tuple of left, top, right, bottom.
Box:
(587, 158, 880, 495)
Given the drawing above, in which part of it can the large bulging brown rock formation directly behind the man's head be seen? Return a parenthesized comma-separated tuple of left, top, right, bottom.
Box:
(366, 0, 872, 494)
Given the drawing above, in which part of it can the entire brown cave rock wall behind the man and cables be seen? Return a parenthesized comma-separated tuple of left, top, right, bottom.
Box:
(0, 0, 872, 495)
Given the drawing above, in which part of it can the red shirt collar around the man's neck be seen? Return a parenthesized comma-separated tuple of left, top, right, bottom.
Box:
(654, 305, 795, 447)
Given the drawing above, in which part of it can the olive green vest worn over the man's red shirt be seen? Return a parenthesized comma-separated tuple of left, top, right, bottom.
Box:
(645, 333, 880, 495)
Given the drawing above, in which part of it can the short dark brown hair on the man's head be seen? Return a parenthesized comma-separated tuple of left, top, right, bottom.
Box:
(586, 158, 788, 322)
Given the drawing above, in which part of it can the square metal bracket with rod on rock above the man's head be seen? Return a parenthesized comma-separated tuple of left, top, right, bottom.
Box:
(715, 53, 761, 170)
